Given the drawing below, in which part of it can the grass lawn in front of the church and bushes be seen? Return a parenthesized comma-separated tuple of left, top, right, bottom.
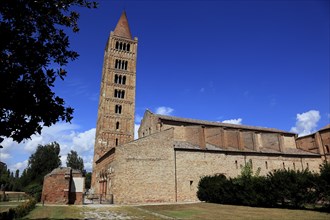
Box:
(25, 203, 330, 220)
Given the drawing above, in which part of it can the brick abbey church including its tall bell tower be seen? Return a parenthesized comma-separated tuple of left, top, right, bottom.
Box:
(92, 12, 330, 204)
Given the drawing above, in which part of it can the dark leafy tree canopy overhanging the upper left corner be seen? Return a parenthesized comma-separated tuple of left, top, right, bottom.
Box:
(0, 0, 97, 143)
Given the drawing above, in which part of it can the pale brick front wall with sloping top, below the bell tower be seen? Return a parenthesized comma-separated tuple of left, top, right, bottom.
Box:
(108, 129, 175, 204)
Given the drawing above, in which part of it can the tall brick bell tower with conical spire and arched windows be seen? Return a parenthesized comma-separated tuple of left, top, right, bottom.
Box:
(92, 12, 137, 191)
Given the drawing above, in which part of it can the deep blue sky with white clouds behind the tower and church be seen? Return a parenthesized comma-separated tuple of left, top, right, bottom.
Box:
(1, 0, 330, 174)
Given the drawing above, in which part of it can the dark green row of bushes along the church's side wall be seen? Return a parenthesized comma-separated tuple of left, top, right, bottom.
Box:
(197, 162, 330, 209)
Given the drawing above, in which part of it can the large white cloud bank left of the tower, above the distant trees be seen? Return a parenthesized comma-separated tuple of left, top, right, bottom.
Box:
(1, 123, 96, 171)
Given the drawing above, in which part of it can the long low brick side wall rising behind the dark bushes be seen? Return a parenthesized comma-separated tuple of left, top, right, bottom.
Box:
(176, 150, 322, 202)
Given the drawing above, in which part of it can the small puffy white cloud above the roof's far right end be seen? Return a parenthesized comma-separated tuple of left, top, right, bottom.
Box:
(290, 110, 321, 136)
